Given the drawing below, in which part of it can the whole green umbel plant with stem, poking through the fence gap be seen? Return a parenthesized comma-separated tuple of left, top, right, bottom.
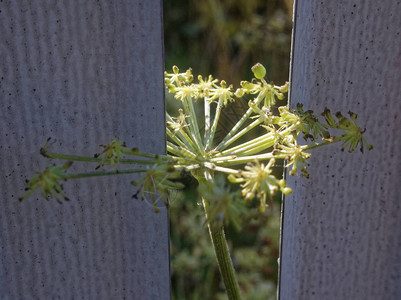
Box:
(21, 63, 372, 299)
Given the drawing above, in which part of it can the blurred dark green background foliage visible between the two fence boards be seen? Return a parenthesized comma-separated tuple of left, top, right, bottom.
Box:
(164, 0, 293, 300)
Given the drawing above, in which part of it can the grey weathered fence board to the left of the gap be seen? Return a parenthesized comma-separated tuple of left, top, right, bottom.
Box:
(0, 0, 170, 300)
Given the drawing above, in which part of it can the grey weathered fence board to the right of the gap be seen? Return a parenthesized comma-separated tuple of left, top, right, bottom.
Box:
(279, 0, 401, 300)
